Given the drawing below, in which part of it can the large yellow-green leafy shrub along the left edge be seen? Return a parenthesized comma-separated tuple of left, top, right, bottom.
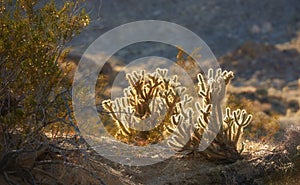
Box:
(0, 0, 89, 181)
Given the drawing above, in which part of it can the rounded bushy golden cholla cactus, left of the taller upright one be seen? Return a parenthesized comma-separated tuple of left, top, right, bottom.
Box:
(102, 68, 191, 142)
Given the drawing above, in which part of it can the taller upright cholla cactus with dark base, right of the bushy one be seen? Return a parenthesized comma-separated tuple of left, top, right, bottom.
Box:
(170, 69, 252, 161)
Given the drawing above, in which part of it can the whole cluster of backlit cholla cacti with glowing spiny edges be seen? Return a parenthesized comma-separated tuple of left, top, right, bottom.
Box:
(102, 64, 252, 161)
